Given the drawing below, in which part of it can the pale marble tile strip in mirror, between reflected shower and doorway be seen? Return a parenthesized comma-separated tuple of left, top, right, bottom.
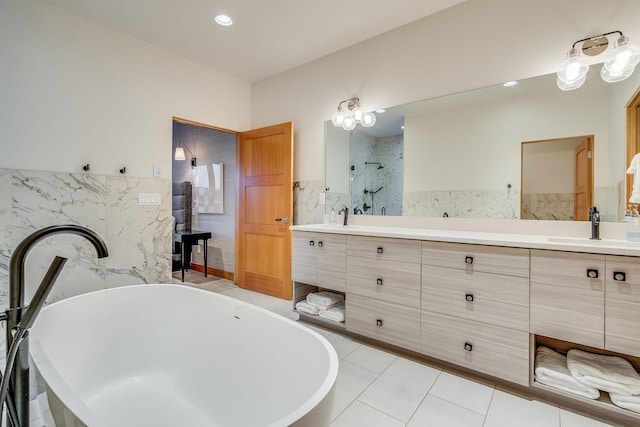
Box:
(403, 188, 520, 219)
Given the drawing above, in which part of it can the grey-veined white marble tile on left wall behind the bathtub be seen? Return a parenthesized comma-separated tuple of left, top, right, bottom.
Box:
(0, 169, 171, 309)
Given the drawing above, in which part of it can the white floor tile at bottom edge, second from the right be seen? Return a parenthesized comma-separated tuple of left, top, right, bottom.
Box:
(484, 390, 560, 427)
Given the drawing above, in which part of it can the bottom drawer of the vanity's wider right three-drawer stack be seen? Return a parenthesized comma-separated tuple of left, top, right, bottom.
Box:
(421, 310, 529, 386)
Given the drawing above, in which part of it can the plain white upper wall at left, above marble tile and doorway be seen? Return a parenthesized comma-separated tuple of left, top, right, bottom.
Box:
(0, 0, 251, 179)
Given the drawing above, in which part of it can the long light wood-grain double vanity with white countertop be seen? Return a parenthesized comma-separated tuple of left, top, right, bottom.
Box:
(292, 224, 640, 424)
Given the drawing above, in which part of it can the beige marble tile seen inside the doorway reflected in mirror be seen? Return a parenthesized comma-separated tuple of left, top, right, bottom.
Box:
(522, 193, 575, 221)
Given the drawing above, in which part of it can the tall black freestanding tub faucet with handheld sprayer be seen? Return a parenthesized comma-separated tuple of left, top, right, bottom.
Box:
(0, 224, 109, 427)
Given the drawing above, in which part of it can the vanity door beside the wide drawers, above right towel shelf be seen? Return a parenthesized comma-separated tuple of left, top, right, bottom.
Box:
(530, 250, 605, 348)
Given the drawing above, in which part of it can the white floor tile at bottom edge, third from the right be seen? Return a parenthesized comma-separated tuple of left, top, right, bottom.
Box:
(407, 395, 482, 427)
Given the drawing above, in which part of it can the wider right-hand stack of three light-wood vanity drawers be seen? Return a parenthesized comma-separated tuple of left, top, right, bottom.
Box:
(420, 242, 529, 386)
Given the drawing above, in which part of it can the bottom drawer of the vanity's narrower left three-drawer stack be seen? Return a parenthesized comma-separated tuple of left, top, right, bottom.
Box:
(345, 294, 420, 351)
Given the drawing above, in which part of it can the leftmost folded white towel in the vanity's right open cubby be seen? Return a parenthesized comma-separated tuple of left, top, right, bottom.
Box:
(534, 346, 600, 399)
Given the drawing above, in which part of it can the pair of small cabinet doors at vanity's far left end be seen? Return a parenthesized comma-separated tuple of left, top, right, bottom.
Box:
(291, 231, 347, 292)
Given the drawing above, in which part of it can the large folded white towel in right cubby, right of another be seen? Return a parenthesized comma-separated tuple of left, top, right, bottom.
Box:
(567, 348, 640, 396)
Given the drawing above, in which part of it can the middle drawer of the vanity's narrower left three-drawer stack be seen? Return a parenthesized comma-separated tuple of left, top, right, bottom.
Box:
(347, 256, 420, 308)
